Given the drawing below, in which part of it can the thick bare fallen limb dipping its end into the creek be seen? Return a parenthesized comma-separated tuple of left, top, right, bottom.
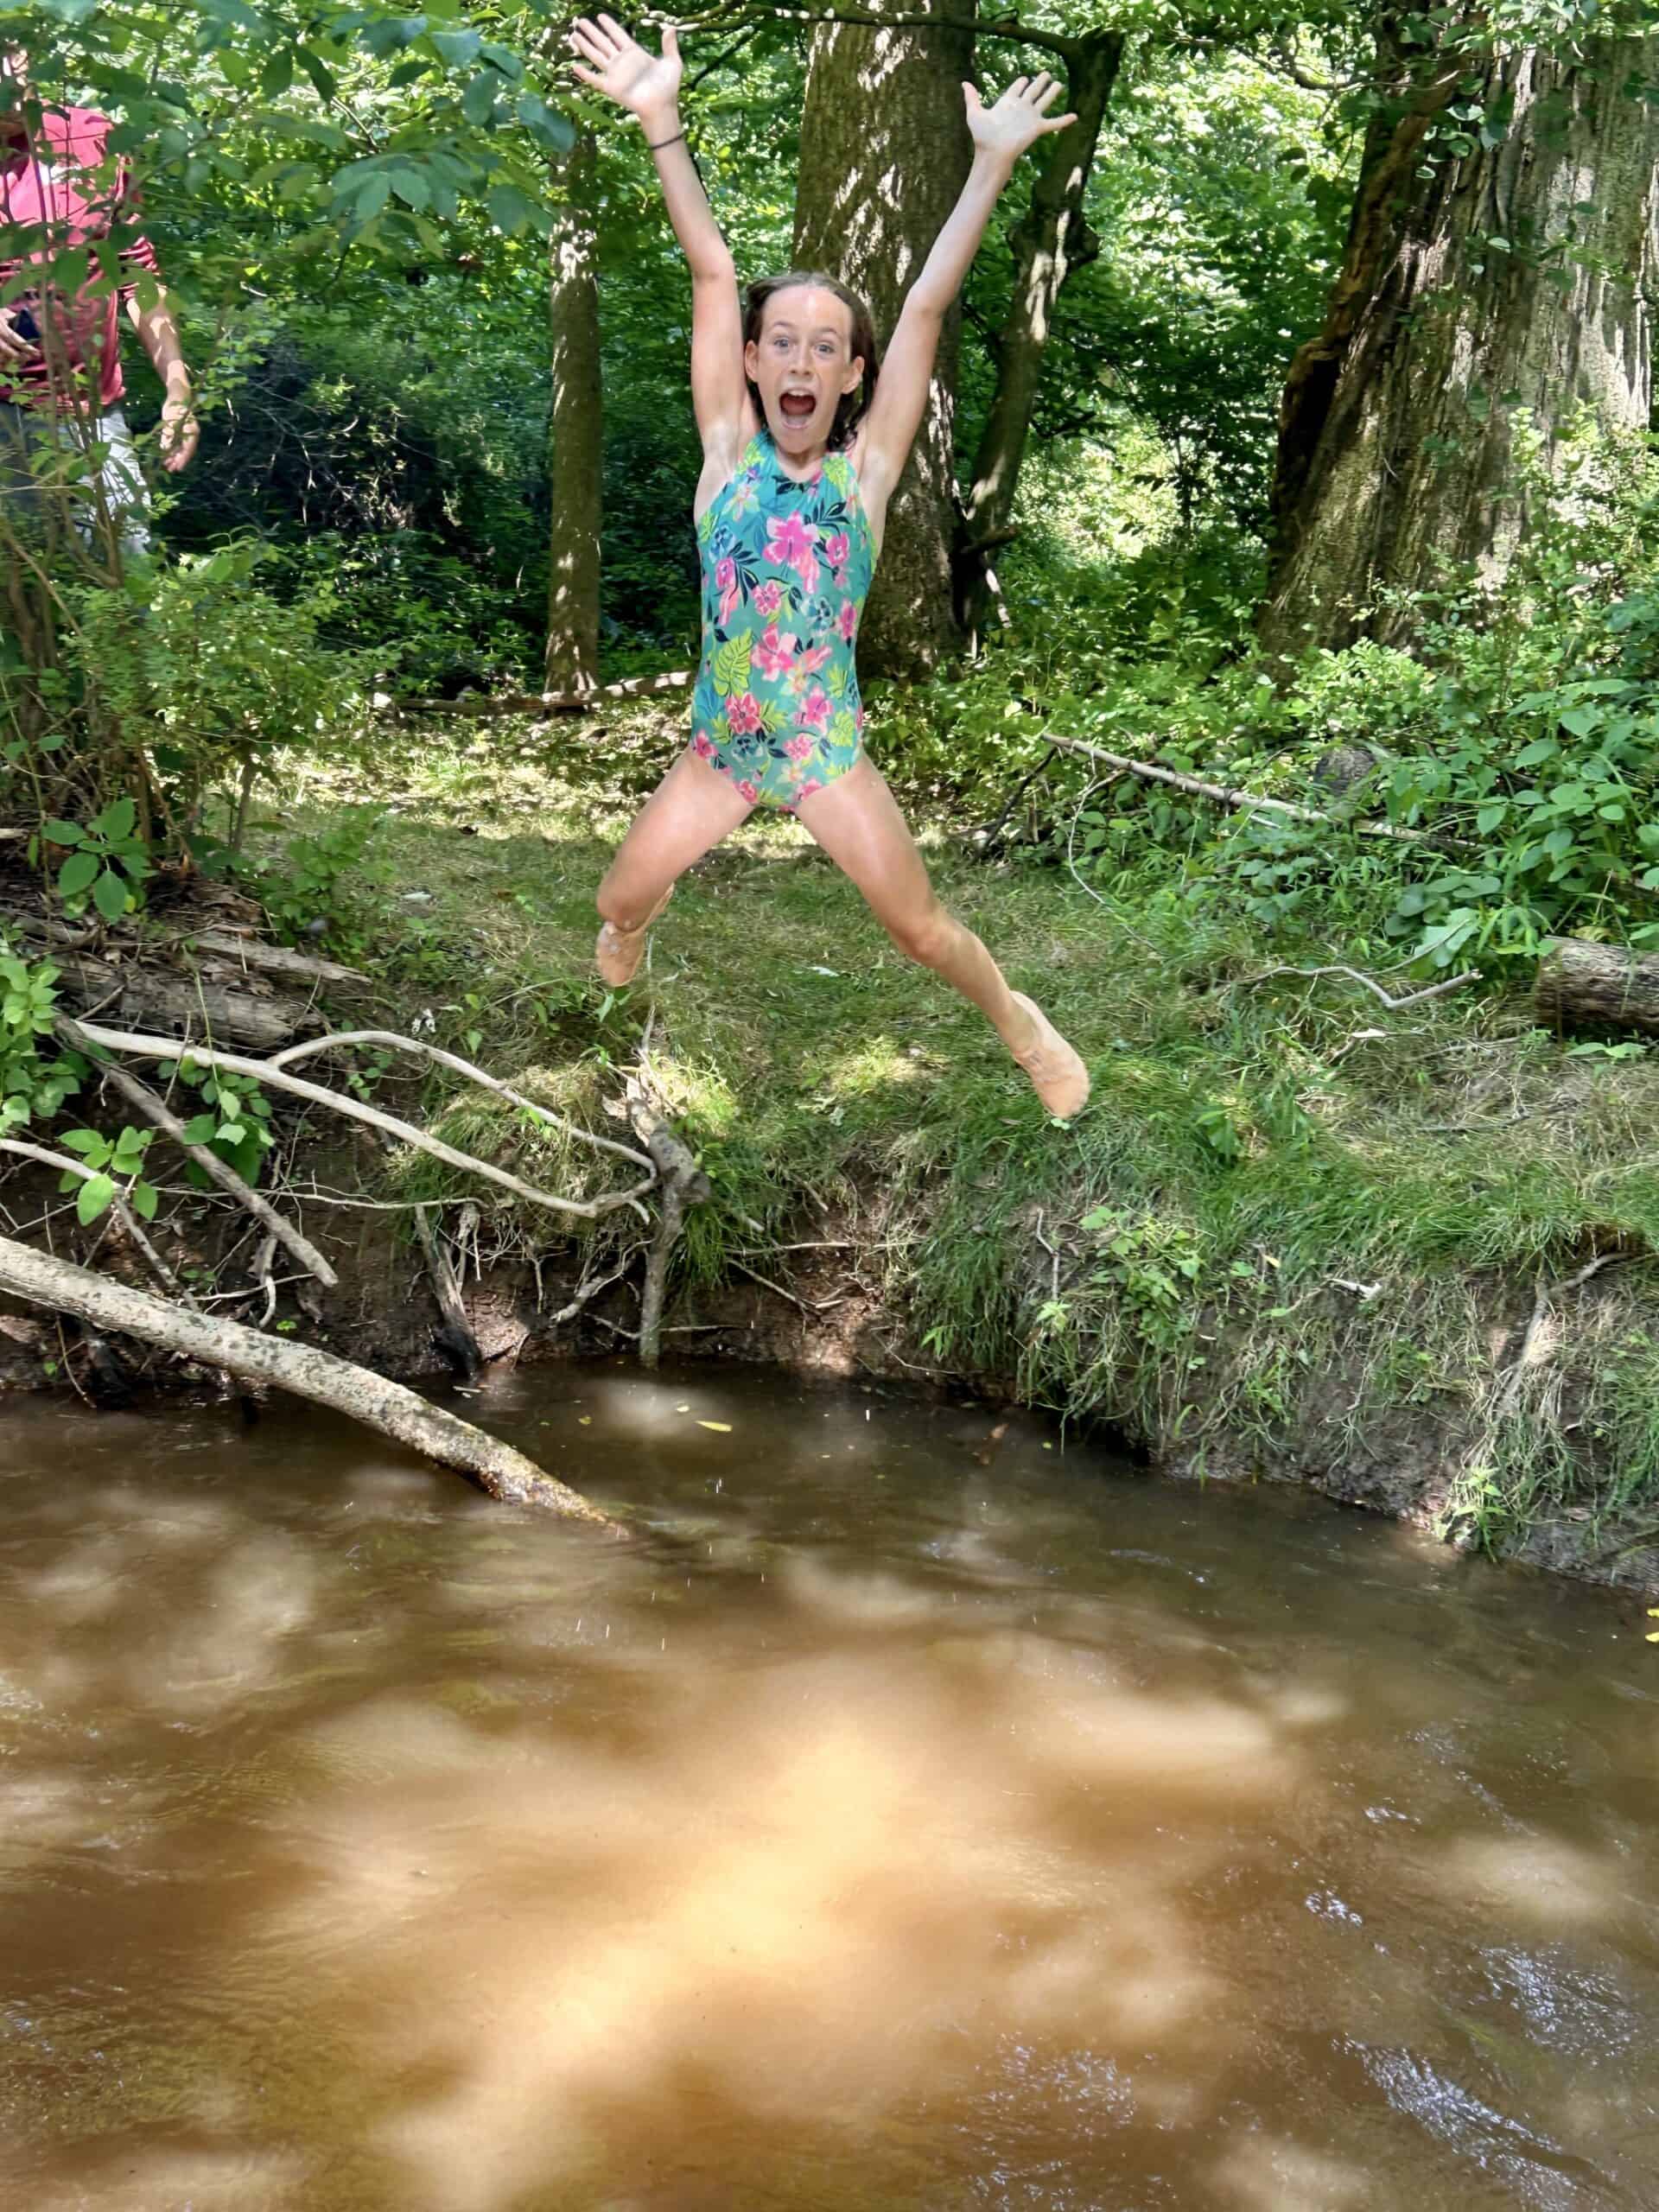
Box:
(0, 1236, 617, 1529)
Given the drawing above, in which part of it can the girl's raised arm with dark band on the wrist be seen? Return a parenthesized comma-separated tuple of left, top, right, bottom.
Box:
(570, 16, 750, 467)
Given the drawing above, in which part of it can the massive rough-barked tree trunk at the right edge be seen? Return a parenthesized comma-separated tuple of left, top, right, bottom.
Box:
(1261, 40, 1659, 657)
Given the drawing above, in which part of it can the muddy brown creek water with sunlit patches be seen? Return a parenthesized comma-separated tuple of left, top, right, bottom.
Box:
(0, 1365, 1659, 2212)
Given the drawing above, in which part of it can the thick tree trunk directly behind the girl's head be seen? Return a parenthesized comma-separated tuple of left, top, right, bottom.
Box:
(794, 0, 973, 675)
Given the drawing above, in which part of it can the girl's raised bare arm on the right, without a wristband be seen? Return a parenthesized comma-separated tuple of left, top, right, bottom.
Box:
(858, 71, 1077, 511)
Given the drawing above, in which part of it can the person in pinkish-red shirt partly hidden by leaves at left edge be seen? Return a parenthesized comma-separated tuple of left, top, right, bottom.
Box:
(0, 48, 201, 553)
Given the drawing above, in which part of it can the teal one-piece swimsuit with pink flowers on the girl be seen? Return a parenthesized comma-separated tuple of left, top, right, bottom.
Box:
(692, 431, 876, 807)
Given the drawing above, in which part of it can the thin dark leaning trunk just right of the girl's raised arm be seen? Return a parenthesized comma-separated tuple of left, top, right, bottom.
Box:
(956, 31, 1123, 628)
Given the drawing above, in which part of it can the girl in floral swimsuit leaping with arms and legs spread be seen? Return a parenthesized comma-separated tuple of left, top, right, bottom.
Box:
(570, 16, 1089, 1117)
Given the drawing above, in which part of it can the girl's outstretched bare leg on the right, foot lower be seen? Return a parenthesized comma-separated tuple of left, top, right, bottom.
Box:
(798, 757, 1089, 1115)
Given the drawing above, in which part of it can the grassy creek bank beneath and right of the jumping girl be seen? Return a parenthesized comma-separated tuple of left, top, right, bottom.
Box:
(264, 710, 1659, 1588)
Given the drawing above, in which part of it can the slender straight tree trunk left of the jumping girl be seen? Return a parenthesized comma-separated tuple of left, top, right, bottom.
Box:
(544, 130, 604, 695)
